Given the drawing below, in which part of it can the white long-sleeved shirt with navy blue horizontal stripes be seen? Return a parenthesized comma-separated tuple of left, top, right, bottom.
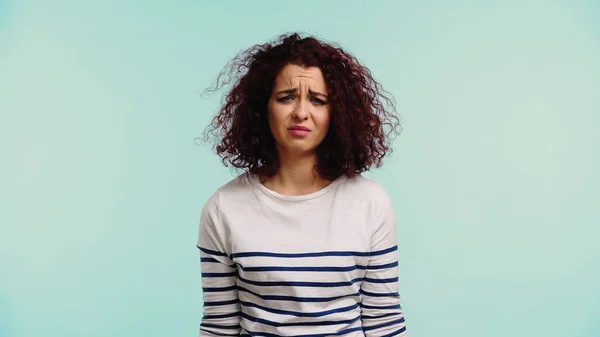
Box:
(197, 173, 408, 337)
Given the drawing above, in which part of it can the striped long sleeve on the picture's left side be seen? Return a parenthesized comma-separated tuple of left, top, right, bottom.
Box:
(196, 192, 241, 337)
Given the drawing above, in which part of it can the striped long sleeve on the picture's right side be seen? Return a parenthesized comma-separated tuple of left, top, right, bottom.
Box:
(361, 195, 408, 337)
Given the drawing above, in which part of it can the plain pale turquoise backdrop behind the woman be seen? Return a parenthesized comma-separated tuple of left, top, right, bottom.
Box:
(0, 0, 600, 337)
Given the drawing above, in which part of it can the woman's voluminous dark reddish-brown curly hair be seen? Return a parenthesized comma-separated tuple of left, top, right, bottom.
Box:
(205, 33, 400, 180)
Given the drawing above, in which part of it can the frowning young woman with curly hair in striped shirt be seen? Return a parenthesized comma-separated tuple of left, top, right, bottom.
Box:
(197, 34, 407, 337)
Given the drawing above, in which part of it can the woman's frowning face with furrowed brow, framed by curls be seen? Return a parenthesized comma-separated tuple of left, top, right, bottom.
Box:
(268, 64, 331, 155)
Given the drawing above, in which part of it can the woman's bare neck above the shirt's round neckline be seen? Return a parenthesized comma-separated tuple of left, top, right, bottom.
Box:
(263, 153, 331, 195)
